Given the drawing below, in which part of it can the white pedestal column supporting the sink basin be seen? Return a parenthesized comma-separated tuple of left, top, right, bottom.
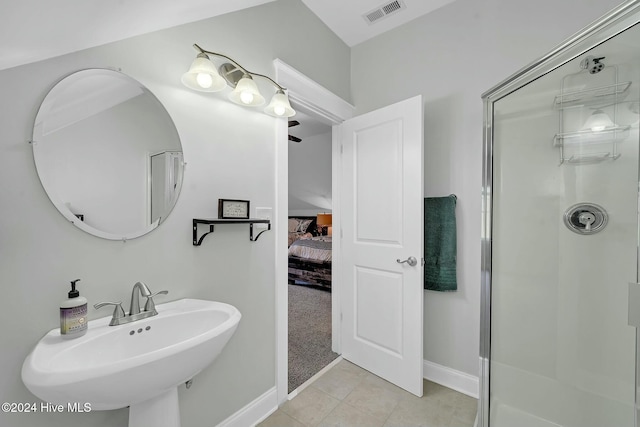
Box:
(129, 387, 180, 427)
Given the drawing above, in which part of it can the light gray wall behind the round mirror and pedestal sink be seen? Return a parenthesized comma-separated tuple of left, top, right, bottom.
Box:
(0, 0, 350, 427)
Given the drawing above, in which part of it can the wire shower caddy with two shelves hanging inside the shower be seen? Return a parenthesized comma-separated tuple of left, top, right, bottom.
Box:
(553, 64, 631, 165)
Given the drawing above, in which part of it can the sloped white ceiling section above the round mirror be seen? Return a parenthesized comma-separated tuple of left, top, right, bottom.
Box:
(0, 0, 274, 70)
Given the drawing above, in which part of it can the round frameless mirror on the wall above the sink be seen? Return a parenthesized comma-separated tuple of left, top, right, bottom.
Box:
(32, 69, 184, 240)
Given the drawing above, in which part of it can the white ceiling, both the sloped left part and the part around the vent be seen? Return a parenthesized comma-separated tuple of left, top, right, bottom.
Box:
(0, 0, 453, 70)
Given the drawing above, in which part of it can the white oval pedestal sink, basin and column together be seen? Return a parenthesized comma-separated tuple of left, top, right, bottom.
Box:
(22, 299, 241, 427)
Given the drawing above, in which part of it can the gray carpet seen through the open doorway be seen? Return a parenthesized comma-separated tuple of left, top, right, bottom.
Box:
(289, 285, 338, 393)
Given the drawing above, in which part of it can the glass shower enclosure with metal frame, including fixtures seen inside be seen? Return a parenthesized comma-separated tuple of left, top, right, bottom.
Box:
(478, 0, 640, 427)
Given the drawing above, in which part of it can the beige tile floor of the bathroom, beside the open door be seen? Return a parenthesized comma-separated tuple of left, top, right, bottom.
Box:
(258, 360, 478, 427)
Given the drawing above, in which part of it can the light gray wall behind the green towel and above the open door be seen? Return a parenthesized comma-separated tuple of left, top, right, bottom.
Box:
(351, 0, 620, 375)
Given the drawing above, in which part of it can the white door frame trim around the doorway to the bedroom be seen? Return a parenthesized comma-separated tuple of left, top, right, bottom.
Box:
(273, 59, 355, 405)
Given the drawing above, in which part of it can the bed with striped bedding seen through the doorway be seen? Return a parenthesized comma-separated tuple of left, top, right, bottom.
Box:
(289, 216, 331, 288)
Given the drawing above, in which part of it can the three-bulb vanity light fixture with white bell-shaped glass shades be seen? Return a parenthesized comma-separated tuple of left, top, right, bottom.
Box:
(182, 44, 296, 117)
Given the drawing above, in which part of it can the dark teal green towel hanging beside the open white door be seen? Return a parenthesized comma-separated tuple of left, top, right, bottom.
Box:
(424, 194, 458, 291)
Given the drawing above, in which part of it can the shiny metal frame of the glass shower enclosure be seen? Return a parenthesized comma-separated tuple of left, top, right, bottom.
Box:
(477, 0, 640, 427)
